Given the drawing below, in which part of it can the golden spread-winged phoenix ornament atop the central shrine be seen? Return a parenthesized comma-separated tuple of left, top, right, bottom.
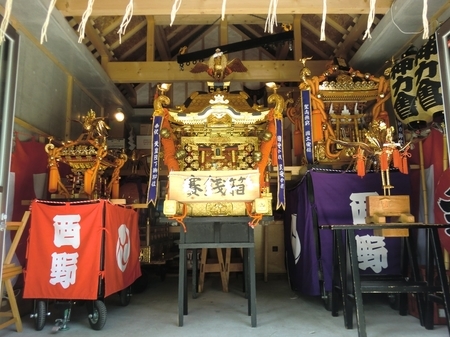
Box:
(191, 48, 247, 82)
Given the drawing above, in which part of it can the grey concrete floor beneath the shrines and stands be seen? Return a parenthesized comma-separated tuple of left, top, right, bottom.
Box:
(0, 274, 449, 337)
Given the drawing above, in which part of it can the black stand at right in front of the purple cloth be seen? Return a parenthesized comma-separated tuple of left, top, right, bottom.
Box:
(319, 223, 450, 337)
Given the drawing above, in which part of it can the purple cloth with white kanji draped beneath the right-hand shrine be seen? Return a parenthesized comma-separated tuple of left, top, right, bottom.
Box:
(284, 170, 410, 296)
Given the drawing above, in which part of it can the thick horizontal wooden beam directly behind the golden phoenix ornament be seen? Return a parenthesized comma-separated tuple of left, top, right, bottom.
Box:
(106, 60, 329, 83)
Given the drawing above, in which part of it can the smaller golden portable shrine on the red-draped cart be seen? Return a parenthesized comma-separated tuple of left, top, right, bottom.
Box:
(45, 110, 127, 199)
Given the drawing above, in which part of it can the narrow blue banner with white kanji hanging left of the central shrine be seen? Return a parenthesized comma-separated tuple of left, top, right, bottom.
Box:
(147, 116, 163, 205)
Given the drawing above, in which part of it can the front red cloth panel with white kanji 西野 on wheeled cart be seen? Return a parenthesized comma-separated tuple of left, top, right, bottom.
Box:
(23, 201, 105, 300)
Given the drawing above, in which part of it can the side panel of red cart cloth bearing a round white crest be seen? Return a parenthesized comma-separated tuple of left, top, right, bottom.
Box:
(105, 203, 141, 296)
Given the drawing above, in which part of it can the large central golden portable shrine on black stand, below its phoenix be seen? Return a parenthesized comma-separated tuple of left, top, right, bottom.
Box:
(148, 82, 285, 225)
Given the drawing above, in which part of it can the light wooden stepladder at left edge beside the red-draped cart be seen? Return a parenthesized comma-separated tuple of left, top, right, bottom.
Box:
(0, 211, 30, 332)
